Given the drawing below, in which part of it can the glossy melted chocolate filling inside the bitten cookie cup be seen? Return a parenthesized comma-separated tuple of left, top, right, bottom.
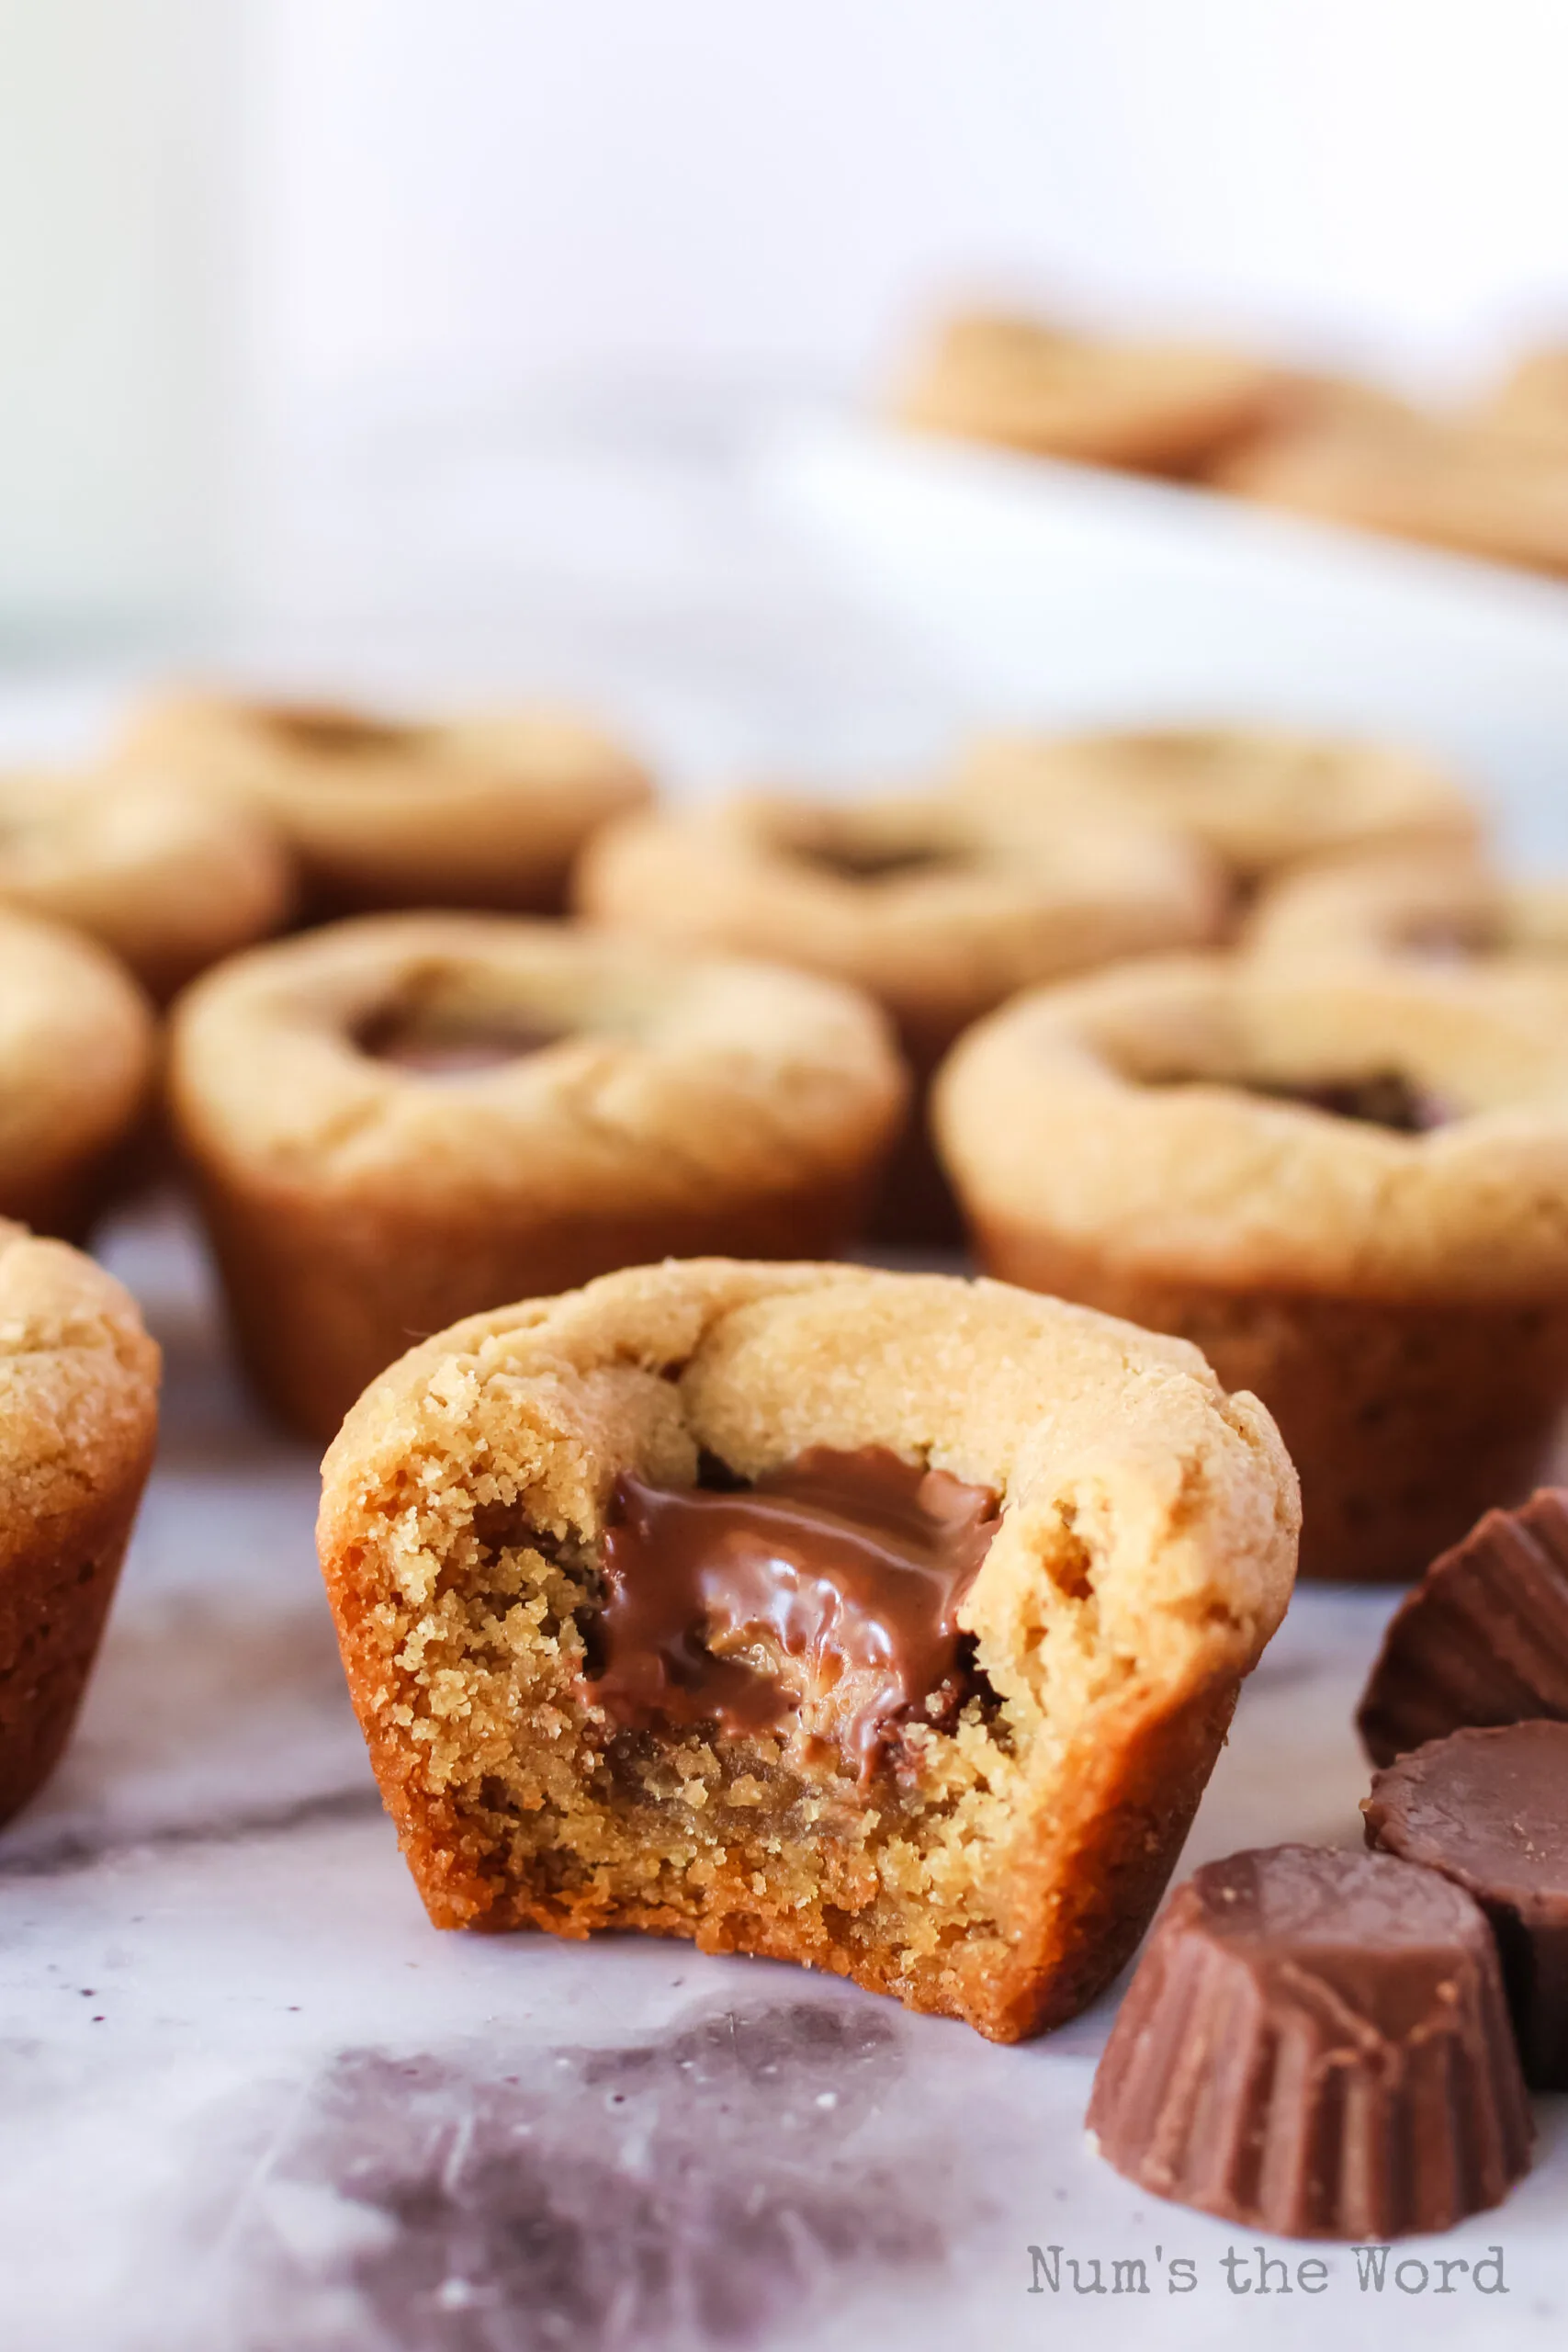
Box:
(590, 1446, 999, 1782)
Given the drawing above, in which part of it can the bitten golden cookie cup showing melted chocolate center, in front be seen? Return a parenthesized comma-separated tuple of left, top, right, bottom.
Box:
(320, 1261, 1295, 2041)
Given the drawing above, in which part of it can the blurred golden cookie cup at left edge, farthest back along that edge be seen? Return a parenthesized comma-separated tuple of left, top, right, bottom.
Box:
(0, 776, 294, 1002)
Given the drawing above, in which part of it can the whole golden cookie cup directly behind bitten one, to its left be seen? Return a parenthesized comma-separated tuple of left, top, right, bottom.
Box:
(172, 915, 905, 1440)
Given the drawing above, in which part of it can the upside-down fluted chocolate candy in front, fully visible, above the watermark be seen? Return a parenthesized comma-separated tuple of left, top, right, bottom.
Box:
(1089, 1847, 1530, 2239)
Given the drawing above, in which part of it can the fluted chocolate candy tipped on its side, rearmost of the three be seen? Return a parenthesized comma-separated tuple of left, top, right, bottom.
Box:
(1357, 1487, 1568, 1764)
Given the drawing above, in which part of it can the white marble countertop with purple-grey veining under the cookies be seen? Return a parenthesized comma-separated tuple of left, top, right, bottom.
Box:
(0, 413, 1568, 2352)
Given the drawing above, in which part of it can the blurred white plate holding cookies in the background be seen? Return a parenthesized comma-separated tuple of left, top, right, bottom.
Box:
(755, 416, 1568, 864)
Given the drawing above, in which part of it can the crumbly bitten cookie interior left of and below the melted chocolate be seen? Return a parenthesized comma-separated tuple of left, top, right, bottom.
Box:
(388, 1425, 1029, 1969)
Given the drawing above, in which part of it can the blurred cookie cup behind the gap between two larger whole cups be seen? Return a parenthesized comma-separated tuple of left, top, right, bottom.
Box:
(576, 793, 1223, 1242)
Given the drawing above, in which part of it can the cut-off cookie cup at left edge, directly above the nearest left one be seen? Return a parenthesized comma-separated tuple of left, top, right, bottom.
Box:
(0, 910, 152, 1238)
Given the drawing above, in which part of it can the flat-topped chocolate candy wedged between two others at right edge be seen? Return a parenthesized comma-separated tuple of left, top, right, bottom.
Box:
(1361, 1722, 1568, 2091)
